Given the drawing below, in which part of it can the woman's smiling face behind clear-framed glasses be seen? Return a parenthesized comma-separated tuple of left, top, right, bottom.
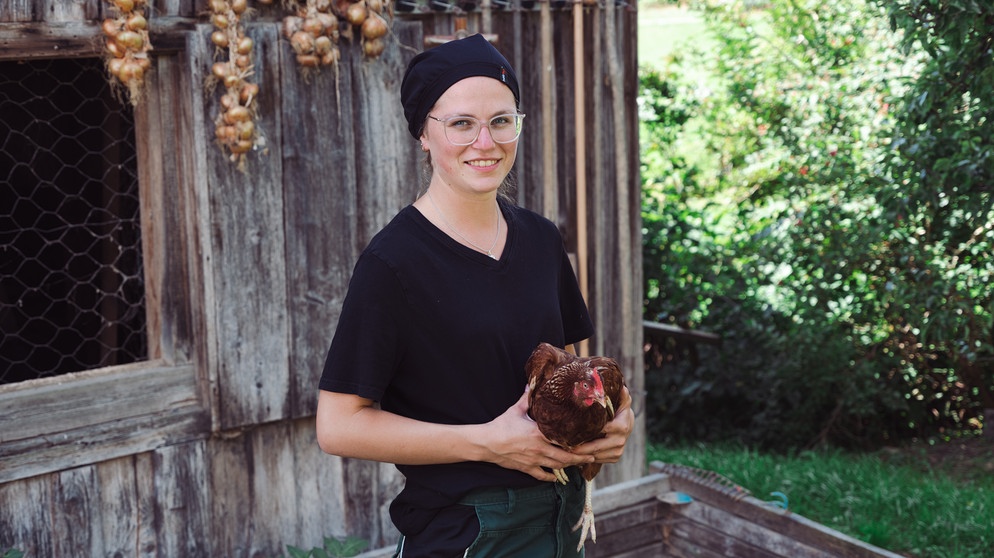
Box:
(421, 76, 518, 199)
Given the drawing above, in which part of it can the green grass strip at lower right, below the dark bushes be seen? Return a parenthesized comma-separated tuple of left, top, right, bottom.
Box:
(648, 442, 994, 558)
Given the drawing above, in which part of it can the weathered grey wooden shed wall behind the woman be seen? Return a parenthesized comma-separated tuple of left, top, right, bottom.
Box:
(0, 0, 645, 556)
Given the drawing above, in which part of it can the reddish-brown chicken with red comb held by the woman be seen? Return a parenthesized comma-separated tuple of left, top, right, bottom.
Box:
(525, 343, 625, 551)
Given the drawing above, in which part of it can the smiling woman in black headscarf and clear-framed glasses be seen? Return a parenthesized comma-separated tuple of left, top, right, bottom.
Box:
(317, 35, 634, 558)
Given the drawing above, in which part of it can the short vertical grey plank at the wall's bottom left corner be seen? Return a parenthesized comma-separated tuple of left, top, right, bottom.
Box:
(0, 476, 55, 556)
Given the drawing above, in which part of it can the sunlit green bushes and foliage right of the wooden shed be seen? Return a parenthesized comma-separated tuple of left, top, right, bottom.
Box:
(641, 0, 994, 446)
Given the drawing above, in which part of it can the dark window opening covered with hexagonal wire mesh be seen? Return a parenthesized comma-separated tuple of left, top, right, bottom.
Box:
(0, 59, 148, 384)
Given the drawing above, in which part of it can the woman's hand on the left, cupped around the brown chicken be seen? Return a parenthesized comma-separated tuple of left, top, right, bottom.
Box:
(481, 390, 592, 482)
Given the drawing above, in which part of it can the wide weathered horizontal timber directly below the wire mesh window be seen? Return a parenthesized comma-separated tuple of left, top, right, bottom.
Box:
(0, 363, 208, 483)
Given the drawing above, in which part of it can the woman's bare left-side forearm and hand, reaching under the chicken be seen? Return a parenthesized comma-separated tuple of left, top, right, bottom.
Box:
(317, 390, 594, 482)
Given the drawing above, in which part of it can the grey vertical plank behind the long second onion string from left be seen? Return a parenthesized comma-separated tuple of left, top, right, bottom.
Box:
(199, 23, 290, 429)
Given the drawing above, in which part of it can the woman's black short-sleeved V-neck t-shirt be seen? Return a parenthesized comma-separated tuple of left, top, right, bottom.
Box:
(320, 203, 593, 535)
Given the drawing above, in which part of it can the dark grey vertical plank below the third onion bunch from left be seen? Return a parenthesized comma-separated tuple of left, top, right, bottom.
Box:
(279, 21, 358, 417)
